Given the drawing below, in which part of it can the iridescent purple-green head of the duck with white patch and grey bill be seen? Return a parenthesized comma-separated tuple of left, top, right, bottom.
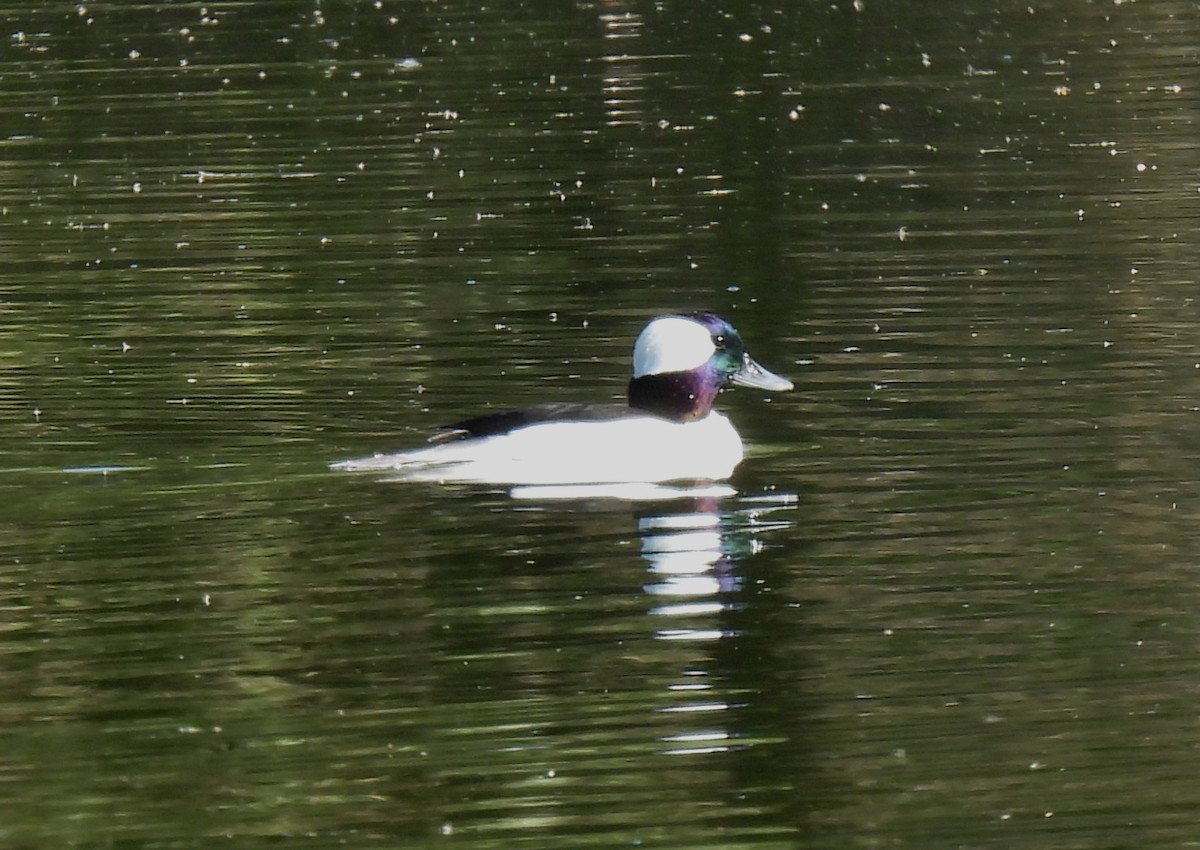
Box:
(629, 313, 792, 421)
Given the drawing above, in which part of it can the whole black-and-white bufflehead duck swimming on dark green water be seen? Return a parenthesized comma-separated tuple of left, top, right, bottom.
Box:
(332, 313, 792, 485)
